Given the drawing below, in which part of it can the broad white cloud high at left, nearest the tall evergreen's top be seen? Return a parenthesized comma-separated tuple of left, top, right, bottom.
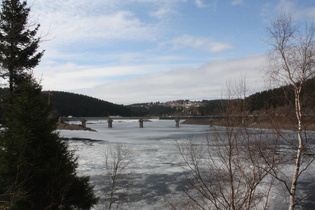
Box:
(41, 11, 157, 44)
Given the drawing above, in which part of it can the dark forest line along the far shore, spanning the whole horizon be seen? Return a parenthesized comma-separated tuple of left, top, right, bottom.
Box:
(0, 78, 315, 117)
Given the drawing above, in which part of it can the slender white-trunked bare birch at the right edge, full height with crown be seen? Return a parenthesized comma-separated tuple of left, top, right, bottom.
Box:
(266, 14, 315, 210)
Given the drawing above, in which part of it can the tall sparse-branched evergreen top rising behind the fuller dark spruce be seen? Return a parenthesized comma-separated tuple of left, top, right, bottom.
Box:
(0, 0, 44, 104)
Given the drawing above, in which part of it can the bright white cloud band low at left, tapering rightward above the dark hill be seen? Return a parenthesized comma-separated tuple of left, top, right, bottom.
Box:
(34, 61, 177, 90)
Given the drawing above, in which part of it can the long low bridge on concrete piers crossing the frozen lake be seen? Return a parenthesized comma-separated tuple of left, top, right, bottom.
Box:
(59, 116, 222, 128)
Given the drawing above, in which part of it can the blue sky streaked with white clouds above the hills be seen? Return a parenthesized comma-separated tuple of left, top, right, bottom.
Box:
(22, 0, 315, 105)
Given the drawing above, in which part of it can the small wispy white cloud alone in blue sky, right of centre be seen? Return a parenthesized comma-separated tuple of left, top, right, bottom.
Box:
(164, 35, 233, 52)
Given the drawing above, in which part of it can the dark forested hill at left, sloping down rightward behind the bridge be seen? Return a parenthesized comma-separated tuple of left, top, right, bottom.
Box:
(43, 91, 133, 117)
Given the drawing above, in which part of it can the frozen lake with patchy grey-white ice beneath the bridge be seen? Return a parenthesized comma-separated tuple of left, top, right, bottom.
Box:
(59, 120, 315, 209)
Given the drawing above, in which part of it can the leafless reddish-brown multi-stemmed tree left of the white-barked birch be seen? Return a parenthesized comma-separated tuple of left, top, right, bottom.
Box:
(172, 77, 282, 210)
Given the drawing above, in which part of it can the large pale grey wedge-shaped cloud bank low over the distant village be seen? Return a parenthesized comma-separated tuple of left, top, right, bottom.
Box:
(75, 55, 265, 104)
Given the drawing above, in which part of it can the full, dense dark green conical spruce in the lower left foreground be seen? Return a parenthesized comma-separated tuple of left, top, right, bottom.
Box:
(0, 79, 97, 209)
